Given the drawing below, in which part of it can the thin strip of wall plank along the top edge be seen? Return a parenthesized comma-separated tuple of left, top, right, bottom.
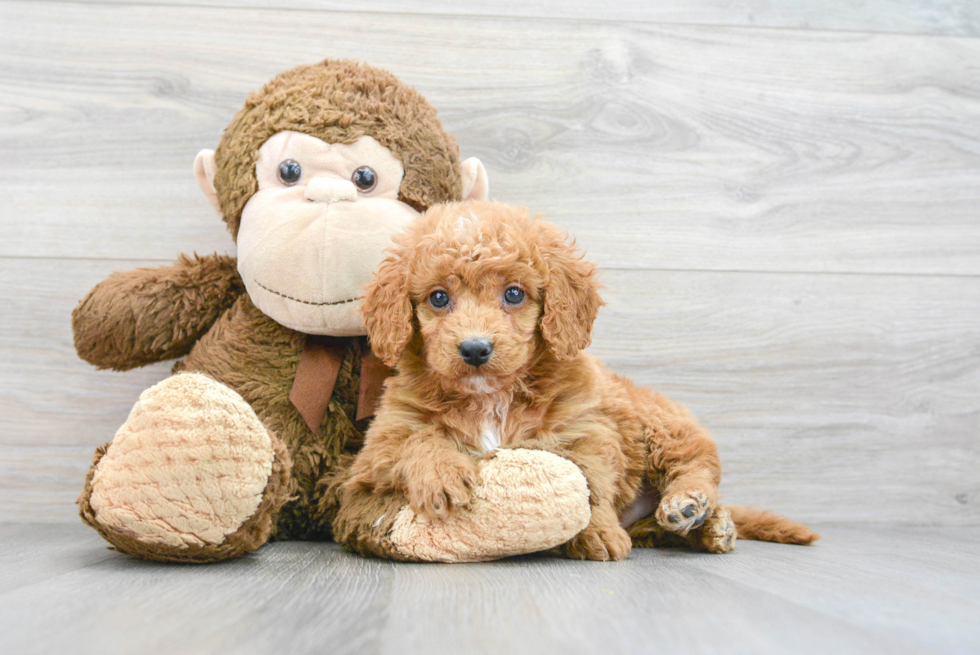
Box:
(55, 0, 980, 36)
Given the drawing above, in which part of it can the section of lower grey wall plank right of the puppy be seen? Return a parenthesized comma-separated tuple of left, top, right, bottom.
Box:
(592, 271, 980, 525)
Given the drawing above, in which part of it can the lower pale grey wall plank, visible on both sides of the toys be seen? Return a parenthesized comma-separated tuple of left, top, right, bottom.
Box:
(0, 259, 980, 525)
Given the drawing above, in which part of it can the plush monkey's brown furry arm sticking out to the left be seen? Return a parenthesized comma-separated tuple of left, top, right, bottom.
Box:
(71, 254, 245, 371)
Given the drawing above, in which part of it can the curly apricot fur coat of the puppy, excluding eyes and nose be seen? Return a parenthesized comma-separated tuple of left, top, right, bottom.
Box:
(345, 202, 805, 560)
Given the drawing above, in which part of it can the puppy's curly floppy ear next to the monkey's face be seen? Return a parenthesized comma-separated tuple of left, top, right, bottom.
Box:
(361, 249, 412, 367)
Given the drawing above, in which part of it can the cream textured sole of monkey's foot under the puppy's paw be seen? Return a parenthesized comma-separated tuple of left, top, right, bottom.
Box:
(387, 449, 592, 562)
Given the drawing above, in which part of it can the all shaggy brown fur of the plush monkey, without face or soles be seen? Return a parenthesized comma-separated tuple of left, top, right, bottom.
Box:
(72, 60, 470, 561)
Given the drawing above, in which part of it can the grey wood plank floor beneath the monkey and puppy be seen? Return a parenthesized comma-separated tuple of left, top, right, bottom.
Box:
(0, 525, 980, 655)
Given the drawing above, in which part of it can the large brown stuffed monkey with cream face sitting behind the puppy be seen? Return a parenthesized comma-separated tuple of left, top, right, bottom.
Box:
(72, 60, 589, 562)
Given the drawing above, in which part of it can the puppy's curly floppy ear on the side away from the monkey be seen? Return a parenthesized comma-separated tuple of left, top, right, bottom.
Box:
(534, 220, 605, 359)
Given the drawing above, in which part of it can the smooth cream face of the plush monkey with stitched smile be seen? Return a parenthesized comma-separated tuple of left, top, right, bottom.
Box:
(238, 132, 418, 336)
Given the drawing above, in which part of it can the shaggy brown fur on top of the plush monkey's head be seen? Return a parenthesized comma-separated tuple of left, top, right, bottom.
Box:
(214, 60, 463, 235)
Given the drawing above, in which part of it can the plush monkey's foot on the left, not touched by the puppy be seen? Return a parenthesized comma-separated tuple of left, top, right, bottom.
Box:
(78, 373, 289, 562)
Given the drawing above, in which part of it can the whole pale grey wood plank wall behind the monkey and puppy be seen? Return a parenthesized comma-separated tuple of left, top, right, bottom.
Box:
(0, 0, 980, 525)
